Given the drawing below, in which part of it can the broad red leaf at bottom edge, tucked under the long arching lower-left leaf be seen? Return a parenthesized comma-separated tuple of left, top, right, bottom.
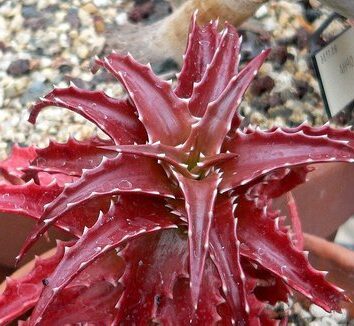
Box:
(28, 252, 124, 326)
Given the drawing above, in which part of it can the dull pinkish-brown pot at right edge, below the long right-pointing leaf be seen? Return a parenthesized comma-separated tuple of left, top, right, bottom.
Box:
(275, 163, 354, 238)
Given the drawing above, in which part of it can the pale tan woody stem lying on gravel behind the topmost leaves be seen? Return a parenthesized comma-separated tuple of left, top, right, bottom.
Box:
(107, 0, 268, 63)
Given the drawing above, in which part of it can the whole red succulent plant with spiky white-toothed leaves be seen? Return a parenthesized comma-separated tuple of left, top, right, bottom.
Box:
(0, 17, 354, 325)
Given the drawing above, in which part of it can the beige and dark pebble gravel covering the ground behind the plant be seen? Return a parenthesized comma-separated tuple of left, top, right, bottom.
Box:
(0, 0, 354, 325)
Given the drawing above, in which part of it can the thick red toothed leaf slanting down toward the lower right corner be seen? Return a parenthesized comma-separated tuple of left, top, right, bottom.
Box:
(235, 197, 345, 310)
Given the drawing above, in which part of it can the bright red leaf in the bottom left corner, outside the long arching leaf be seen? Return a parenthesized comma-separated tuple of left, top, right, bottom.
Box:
(0, 242, 68, 325)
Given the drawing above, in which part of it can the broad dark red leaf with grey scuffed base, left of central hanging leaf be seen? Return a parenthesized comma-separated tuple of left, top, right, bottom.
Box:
(116, 230, 188, 325)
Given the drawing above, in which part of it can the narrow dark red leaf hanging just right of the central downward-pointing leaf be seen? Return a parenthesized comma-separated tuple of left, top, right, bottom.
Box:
(210, 198, 252, 325)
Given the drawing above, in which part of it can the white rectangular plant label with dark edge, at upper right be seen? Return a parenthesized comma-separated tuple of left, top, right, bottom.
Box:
(313, 27, 354, 118)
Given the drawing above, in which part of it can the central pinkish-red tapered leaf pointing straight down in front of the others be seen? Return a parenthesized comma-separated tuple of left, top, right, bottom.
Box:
(177, 174, 219, 309)
